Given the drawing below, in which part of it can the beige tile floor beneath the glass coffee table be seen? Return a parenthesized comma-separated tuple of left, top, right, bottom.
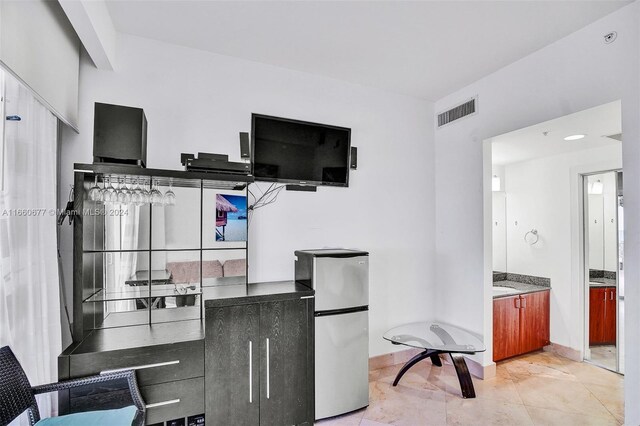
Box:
(316, 352, 624, 426)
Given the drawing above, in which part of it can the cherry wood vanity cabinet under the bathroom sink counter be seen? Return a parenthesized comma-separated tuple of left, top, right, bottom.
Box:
(493, 290, 549, 361)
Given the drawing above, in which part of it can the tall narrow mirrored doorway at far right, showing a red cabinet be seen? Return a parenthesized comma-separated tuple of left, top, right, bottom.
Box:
(583, 170, 624, 374)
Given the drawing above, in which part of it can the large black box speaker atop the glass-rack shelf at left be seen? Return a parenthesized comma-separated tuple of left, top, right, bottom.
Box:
(93, 102, 147, 167)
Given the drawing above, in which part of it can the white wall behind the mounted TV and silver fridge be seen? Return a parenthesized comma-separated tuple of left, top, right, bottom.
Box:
(61, 36, 435, 356)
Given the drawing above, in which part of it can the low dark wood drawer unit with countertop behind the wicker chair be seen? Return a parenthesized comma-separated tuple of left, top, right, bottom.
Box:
(58, 320, 205, 424)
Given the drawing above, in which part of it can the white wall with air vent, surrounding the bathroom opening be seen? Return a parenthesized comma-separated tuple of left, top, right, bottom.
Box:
(435, 2, 640, 424)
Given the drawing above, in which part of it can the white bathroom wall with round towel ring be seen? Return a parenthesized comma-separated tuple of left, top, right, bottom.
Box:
(505, 145, 622, 351)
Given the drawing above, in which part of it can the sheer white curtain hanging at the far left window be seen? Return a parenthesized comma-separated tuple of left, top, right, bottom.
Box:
(0, 70, 62, 424)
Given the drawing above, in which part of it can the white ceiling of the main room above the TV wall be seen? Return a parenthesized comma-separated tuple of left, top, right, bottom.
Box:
(102, 0, 629, 100)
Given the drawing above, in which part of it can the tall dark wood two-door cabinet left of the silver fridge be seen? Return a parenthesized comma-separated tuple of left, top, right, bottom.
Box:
(205, 298, 314, 425)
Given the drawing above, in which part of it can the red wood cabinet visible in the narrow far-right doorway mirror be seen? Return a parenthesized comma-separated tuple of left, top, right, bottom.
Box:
(589, 287, 617, 345)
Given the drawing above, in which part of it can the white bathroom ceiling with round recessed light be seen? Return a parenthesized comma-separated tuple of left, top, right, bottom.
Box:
(491, 101, 622, 166)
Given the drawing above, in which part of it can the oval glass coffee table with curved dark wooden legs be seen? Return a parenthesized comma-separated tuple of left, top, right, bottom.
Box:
(382, 322, 486, 398)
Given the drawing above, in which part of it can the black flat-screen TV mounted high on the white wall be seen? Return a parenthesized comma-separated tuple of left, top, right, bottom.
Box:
(251, 114, 351, 186)
